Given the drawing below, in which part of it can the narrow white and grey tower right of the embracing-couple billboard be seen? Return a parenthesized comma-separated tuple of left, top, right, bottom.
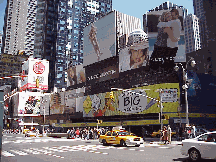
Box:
(184, 14, 201, 53)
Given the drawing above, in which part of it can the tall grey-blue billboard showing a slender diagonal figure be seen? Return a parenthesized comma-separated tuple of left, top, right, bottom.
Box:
(83, 12, 116, 66)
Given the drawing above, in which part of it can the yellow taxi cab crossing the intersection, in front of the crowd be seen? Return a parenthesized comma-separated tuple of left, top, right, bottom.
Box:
(99, 130, 144, 147)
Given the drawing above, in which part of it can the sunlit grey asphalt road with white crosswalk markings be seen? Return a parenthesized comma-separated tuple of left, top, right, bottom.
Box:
(1, 134, 215, 162)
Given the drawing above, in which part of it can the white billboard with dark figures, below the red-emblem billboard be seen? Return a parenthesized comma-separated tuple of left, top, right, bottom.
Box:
(18, 92, 43, 116)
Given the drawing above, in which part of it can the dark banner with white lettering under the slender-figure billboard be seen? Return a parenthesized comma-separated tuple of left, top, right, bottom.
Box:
(86, 57, 119, 83)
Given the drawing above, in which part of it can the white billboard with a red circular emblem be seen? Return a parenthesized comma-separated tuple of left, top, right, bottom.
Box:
(21, 58, 49, 91)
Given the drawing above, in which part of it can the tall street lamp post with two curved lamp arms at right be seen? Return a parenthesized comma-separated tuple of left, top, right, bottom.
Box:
(175, 57, 196, 124)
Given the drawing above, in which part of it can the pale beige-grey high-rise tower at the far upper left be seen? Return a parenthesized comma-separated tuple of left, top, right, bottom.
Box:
(2, 0, 37, 55)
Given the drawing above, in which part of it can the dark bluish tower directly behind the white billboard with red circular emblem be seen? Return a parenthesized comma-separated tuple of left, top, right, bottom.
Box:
(33, 0, 60, 91)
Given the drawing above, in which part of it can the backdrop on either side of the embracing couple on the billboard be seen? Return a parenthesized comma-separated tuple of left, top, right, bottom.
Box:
(144, 8, 186, 62)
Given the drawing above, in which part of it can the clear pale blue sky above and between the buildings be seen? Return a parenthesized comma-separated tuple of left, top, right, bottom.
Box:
(0, 0, 194, 31)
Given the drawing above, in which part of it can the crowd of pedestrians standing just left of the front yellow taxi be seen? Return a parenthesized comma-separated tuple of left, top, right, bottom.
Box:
(67, 127, 106, 140)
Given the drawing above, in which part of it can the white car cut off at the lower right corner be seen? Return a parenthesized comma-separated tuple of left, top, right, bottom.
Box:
(181, 131, 216, 161)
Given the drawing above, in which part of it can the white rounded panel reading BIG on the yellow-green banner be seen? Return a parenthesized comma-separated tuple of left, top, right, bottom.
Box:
(118, 89, 147, 113)
